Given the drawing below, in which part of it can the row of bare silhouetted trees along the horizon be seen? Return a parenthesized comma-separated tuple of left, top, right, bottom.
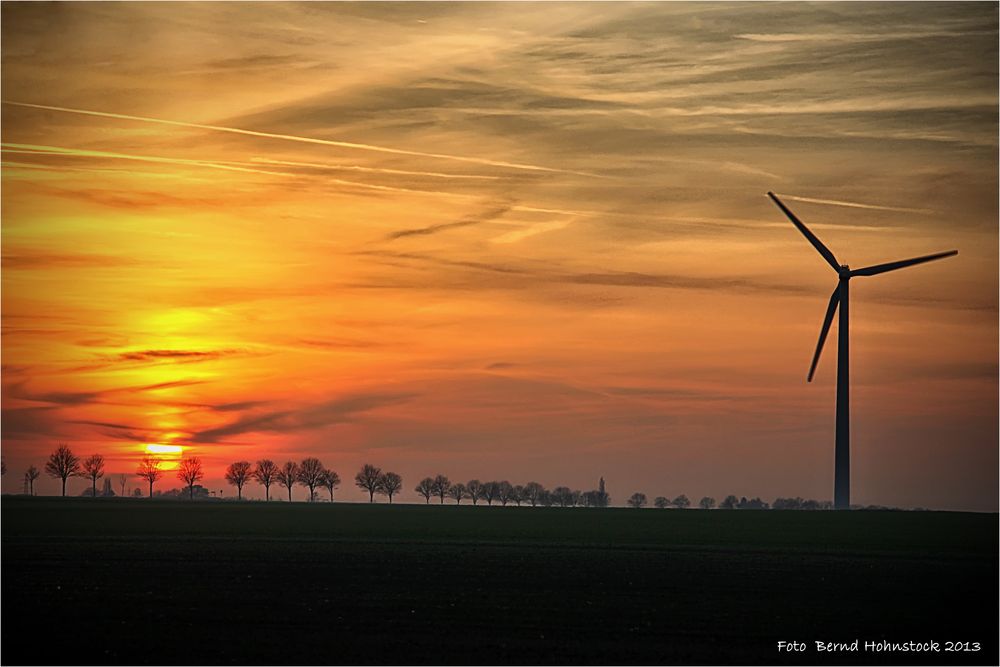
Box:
(3, 444, 832, 510)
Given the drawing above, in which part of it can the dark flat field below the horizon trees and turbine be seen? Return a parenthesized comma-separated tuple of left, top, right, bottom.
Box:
(0, 497, 998, 664)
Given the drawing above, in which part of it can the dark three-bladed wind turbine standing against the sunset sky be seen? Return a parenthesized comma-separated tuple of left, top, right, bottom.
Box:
(767, 192, 958, 510)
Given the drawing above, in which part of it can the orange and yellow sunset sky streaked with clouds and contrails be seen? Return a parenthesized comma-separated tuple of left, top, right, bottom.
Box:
(2, 2, 998, 511)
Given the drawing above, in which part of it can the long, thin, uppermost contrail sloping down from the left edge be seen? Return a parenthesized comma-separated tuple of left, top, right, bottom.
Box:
(2, 100, 605, 178)
